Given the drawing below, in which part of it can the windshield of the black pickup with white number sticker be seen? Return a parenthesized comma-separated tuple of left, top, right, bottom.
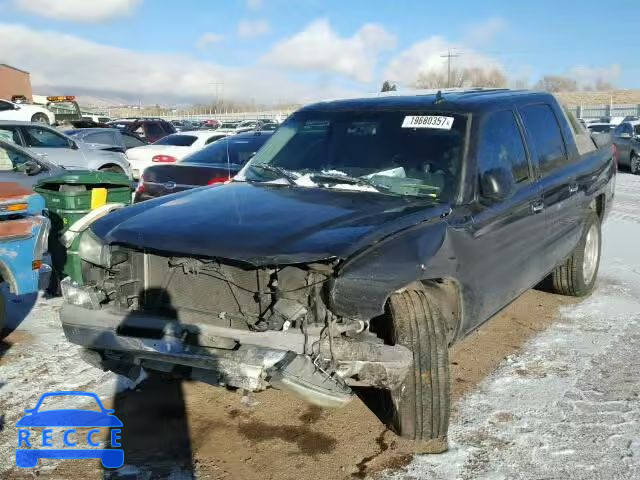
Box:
(238, 110, 467, 201)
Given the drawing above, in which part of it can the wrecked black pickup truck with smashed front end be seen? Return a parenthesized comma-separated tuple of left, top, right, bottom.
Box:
(61, 90, 616, 452)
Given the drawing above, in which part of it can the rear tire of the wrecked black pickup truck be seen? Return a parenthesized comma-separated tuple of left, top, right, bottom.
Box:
(551, 211, 602, 297)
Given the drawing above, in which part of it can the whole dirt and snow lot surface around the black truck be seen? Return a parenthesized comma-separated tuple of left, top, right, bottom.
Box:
(0, 174, 640, 480)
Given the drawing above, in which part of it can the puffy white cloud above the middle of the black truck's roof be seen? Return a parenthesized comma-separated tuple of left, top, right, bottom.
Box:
(263, 19, 396, 82)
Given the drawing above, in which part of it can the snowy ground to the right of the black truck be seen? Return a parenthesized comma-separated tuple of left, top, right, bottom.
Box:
(387, 175, 640, 480)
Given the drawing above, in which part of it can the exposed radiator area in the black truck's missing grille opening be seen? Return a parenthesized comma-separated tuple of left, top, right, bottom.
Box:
(95, 247, 333, 331)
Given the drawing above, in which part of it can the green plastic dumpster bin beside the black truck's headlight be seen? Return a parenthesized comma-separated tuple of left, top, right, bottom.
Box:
(34, 170, 133, 284)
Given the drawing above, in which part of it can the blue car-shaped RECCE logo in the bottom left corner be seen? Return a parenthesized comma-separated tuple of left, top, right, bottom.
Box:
(16, 392, 124, 468)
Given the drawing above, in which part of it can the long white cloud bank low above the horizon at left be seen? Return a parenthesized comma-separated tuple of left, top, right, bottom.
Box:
(0, 23, 356, 103)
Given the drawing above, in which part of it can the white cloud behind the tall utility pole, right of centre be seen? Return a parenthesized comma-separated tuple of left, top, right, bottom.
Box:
(384, 36, 504, 85)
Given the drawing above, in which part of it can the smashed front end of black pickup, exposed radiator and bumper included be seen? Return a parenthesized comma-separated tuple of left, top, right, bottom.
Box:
(61, 234, 412, 407)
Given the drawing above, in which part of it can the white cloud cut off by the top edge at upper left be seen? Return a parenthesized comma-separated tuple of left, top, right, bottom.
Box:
(13, 0, 143, 22)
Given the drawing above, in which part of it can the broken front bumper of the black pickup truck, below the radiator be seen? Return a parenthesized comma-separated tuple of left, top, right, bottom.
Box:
(60, 303, 413, 398)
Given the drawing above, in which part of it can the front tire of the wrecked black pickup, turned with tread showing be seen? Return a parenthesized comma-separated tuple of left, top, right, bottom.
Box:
(363, 290, 450, 453)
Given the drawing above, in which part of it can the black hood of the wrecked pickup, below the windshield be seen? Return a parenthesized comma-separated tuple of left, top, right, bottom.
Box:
(91, 182, 449, 265)
